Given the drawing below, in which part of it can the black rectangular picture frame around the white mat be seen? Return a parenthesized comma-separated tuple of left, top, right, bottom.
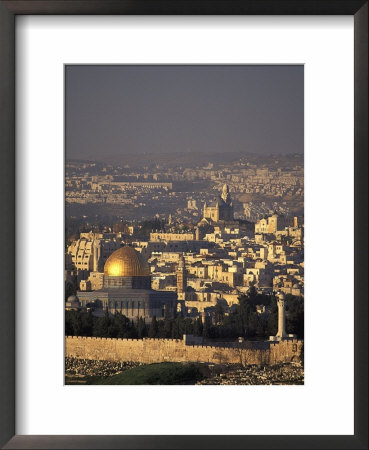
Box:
(0, 0, 368, 449)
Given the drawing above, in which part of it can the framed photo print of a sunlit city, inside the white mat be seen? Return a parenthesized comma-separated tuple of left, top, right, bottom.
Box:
(63, 65, 304, 385)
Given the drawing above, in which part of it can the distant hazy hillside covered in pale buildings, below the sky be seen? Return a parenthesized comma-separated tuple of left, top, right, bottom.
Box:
(65, 155, 304, 222)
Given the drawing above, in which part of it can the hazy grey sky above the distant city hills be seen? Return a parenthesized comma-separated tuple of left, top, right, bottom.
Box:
(66, 65, 304, 159)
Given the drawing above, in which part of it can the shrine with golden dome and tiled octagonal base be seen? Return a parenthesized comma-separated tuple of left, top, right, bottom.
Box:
(77, 246, 177, 323)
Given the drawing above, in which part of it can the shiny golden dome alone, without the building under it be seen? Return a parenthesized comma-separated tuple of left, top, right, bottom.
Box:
(104, 247, 150, 277)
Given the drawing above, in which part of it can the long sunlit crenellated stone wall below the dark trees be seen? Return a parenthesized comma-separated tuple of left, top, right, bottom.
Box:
(65, 336, 302, 365)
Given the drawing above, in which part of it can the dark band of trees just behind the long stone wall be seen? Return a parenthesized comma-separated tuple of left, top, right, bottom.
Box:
(65, 289, 304, 339)
